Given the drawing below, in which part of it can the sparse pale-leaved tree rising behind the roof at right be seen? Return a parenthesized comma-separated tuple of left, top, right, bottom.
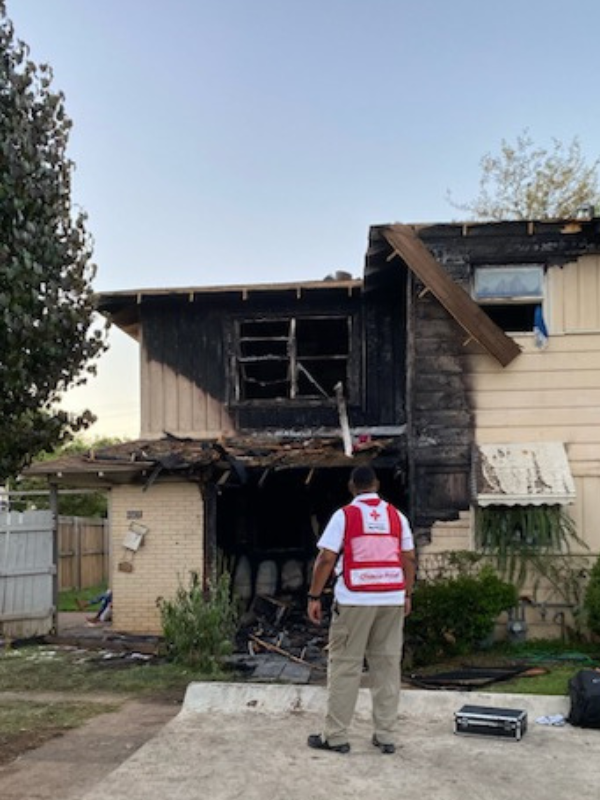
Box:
(448, 130, 600, 220)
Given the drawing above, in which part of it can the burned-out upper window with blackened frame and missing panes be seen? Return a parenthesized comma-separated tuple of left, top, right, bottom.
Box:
(235, 317, 351, 400)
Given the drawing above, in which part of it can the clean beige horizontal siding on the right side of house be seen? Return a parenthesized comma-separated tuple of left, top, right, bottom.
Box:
(465, 256, 600, 552)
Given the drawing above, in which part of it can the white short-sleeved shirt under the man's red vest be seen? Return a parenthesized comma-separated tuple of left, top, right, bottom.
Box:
(317, 492, 415, 606)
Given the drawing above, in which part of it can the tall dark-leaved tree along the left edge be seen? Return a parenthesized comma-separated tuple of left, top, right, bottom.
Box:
(0, 0, 106, 481)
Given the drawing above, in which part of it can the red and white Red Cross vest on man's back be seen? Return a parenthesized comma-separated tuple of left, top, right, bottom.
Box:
(343, 498, 404, 592)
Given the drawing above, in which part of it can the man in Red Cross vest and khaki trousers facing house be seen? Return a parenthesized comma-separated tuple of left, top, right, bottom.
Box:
(308, 466, 415, 754)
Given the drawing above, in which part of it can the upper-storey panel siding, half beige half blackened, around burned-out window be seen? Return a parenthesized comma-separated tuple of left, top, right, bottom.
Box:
(138, 280, 406, 438)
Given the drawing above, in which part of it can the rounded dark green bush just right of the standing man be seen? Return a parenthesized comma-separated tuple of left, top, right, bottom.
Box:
(405, 566, 518, 664)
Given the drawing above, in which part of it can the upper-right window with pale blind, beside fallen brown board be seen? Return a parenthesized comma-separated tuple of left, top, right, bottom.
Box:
(473, 264, 544, 333)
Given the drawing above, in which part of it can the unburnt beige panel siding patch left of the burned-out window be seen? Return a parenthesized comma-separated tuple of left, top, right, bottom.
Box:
(140, 345, 234, 439)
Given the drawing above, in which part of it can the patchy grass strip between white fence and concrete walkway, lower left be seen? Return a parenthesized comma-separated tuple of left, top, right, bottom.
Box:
(0, 646, 231, 696)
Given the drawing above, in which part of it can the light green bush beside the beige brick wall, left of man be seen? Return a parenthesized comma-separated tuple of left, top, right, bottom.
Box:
(157, 573, 237, 675)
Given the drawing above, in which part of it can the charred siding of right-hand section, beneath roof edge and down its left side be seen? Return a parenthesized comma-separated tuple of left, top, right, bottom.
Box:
(406, 219, 600, 535)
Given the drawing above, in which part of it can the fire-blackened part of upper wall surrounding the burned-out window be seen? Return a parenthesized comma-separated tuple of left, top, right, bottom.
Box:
(141, 283, 405, 430)
